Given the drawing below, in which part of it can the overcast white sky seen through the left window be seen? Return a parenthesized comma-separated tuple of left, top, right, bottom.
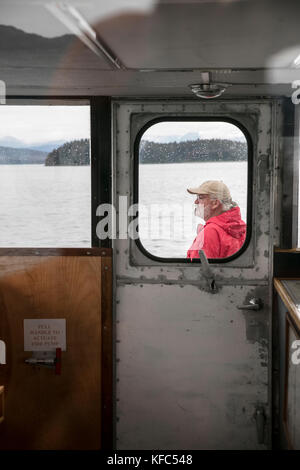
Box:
(0, 105, 90, 144)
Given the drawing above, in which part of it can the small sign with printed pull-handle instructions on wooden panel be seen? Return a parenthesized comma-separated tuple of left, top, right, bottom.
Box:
(24, 318, 66, 351)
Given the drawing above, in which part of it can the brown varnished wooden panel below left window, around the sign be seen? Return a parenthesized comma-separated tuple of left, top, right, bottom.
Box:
(0, 256, 106, 449)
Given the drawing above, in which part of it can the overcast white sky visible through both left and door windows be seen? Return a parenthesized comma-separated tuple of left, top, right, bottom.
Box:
(0, 105, 245, 144)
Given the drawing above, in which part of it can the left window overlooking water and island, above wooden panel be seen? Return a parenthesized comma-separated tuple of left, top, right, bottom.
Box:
(0, 102, 91, 247)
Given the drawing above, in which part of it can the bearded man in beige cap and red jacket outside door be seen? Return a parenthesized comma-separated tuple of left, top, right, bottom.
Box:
(187, 181, 246, 261)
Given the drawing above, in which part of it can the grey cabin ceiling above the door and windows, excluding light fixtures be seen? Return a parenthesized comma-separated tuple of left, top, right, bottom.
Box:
(0, 0, 300, 98)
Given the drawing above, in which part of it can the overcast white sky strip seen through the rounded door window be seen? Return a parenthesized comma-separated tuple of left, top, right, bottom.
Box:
(143, 121, 246, 141)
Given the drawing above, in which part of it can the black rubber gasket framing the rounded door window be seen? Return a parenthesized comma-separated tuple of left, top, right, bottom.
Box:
(133, 116, 253, 265)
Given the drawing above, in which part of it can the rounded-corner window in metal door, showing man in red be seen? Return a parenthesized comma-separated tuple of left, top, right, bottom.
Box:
(135, 118, 252, 263)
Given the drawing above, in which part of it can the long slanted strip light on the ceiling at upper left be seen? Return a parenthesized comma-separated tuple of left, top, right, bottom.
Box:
(45, 2, 126, 69)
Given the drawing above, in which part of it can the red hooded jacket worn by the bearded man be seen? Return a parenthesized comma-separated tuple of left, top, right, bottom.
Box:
(187, 207, 247, 260)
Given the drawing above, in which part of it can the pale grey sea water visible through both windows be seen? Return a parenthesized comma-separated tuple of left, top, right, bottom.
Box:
(0, 162, 300, 258)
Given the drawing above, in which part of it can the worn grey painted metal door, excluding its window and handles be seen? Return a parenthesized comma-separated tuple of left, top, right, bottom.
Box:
(113, 101, 278, 449)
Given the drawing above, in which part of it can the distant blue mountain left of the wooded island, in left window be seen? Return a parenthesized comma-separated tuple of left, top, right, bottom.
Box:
(0, 147, 48, 165)
